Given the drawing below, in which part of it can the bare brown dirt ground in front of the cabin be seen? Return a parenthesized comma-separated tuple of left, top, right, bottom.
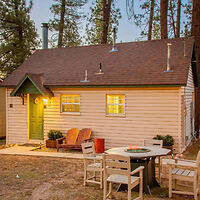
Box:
(0, 155, 197, 200)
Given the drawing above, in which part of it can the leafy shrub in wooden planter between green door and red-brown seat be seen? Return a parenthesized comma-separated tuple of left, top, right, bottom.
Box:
(46, 130, 63, 148)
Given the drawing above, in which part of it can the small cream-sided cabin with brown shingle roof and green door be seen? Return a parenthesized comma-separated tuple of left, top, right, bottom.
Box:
(2, 38, 197, 152)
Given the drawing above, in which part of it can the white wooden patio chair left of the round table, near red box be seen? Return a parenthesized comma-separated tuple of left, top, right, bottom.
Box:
(81, 142, 103, 189)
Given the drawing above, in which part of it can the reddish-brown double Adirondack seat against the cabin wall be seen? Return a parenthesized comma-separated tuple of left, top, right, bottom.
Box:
(56, 128, 92, 151)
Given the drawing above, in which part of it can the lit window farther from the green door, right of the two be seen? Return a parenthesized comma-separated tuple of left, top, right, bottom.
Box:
(107, 95, 125, 115)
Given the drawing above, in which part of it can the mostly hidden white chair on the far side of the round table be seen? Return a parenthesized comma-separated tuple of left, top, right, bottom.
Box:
(143, 139, 163, 184)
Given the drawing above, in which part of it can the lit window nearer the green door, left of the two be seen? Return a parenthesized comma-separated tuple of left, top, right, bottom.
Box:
(61, 95, 80, 113)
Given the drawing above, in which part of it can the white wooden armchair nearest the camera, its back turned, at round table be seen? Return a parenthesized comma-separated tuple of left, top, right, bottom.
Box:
(103, 154, 144, 200)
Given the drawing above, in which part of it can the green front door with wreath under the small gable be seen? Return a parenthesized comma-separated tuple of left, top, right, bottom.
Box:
(29, 94, 44, 140)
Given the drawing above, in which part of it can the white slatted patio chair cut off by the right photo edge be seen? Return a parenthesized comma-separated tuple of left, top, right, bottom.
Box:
(168, 151, 200, 200)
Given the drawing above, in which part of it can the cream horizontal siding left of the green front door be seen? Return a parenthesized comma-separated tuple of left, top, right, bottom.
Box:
(6, 89, 27, 144)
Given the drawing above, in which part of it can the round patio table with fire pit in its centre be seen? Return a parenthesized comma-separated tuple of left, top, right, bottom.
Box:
(105, 146, 171, 194)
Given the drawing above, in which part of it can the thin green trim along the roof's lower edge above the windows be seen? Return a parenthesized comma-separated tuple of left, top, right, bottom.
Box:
(46, 84, 186, 88)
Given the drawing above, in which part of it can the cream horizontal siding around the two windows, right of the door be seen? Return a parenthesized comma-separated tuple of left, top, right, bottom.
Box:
(44, 88, 181, 152)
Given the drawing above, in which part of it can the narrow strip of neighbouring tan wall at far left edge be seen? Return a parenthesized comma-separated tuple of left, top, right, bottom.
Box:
(0, 88, 6, 137)
